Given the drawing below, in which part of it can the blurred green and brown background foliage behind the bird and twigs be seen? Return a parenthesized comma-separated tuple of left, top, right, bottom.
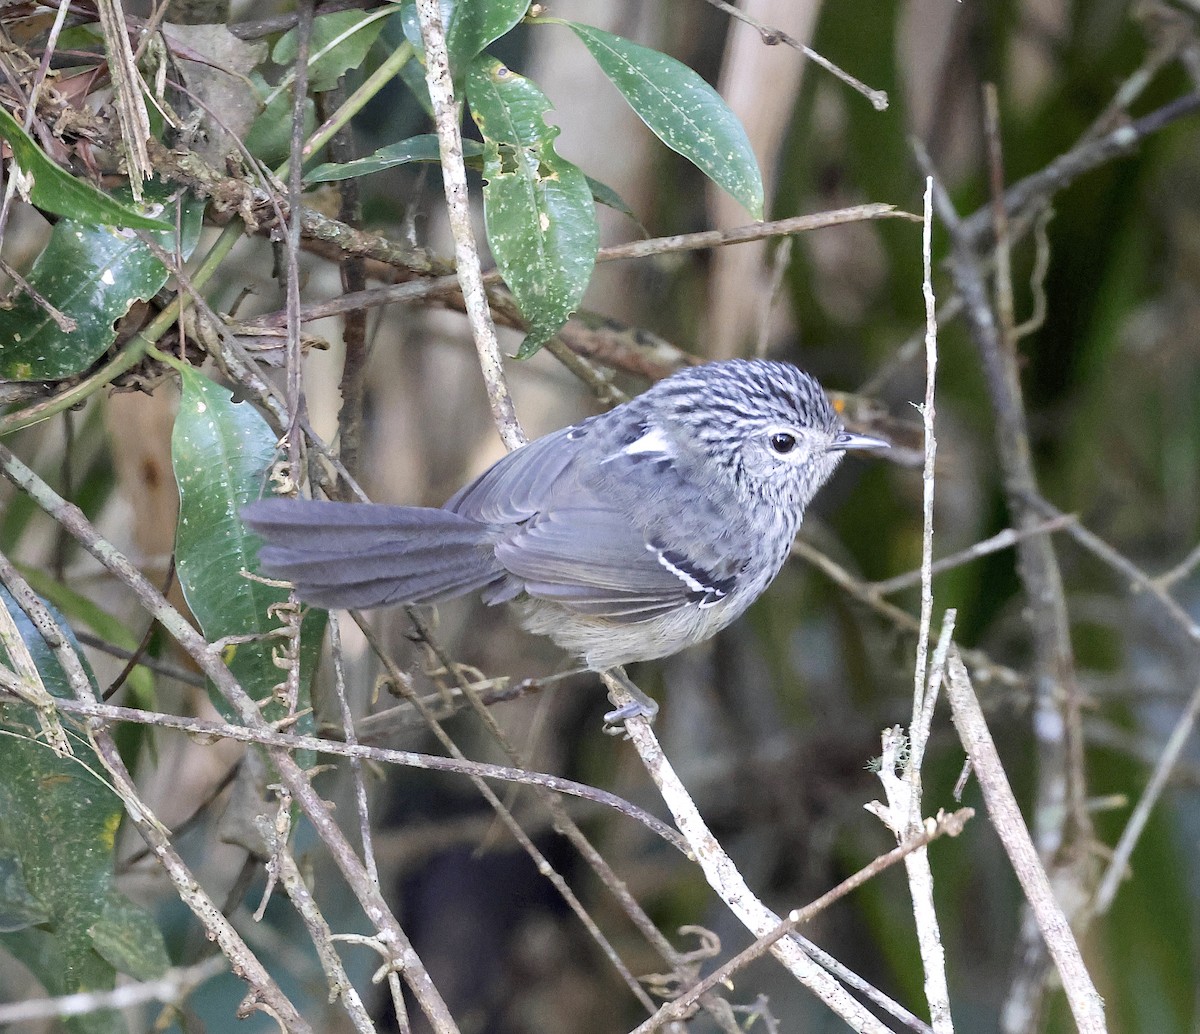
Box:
(0, 0, 1200, 1034)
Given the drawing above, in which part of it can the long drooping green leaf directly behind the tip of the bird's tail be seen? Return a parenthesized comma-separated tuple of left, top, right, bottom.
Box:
(170, 368, 324, 721)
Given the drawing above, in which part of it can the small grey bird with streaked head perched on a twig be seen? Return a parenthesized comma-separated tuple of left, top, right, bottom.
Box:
(242, 359, 887, 720)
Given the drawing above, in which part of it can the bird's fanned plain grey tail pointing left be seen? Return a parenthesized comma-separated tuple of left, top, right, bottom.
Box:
(241, 499, 504, 609)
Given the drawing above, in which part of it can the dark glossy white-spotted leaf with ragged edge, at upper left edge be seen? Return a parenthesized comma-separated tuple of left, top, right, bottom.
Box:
(0, 184, 204, 380)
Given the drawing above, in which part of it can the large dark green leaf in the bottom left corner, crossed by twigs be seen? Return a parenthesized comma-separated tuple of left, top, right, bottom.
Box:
(0, 589, 169, 1034)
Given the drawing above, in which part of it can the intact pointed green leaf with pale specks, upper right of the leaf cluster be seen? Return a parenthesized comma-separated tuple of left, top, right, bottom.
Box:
(549, 18, 763, 220)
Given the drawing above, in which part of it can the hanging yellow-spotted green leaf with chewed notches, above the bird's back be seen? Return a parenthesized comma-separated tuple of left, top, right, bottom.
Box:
(467, 55, 600, 359)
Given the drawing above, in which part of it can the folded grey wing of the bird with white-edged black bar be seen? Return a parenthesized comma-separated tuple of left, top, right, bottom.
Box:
(496, 504, 745, 621)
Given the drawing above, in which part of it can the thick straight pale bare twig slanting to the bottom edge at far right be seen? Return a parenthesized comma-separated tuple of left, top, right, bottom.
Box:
(947, 650, 1106, 1034)
